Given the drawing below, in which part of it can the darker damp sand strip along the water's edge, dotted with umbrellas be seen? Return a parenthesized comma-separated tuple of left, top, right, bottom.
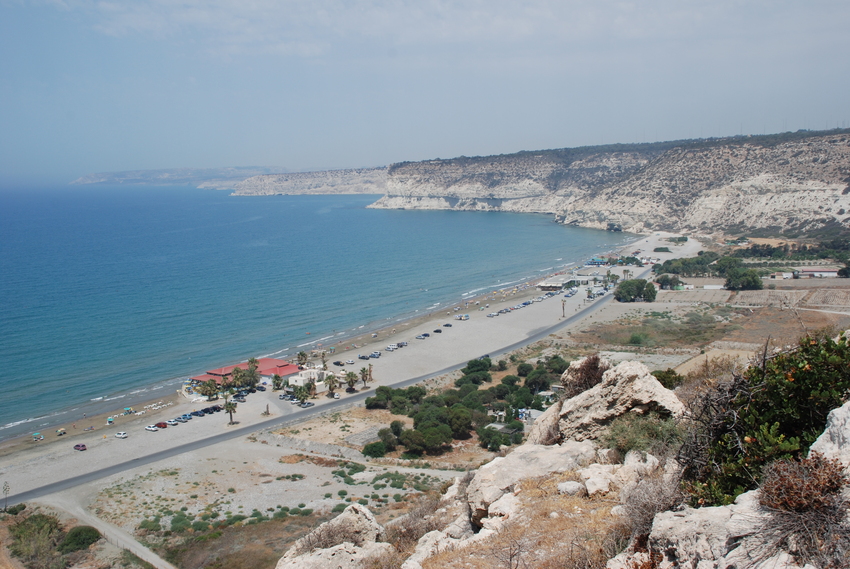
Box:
(0, 234, 649, 456)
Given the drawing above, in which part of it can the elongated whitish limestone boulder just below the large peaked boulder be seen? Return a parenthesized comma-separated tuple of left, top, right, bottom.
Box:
(467, 441, 596, 527)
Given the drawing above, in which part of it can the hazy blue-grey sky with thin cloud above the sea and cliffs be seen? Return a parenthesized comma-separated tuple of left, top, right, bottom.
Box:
(0, 0, 850, 187)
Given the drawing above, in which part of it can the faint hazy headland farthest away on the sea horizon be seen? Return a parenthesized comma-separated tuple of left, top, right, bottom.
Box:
(71, 166, 285, 190)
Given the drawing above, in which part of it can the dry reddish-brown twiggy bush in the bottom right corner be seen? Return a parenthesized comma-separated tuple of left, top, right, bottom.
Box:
(759, 453, 850, 567)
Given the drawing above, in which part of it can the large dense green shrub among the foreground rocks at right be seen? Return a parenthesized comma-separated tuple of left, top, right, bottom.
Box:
(678, 334, 850, 504)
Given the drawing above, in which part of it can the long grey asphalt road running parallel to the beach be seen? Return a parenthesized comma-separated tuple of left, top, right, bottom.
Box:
(4, 269, 651, 504)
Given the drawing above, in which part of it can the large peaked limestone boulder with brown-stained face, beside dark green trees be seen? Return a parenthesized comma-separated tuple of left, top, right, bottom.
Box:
(558, 361, 685, 441)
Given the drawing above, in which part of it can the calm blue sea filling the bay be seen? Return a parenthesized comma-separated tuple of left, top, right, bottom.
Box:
(0, 186, 633, 440)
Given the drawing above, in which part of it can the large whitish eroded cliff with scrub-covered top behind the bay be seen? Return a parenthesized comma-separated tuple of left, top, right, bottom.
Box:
(371, 134, 850, 233)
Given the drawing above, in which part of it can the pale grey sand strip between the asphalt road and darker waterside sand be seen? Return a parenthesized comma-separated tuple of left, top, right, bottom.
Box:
(0, 230, 700, 503)
